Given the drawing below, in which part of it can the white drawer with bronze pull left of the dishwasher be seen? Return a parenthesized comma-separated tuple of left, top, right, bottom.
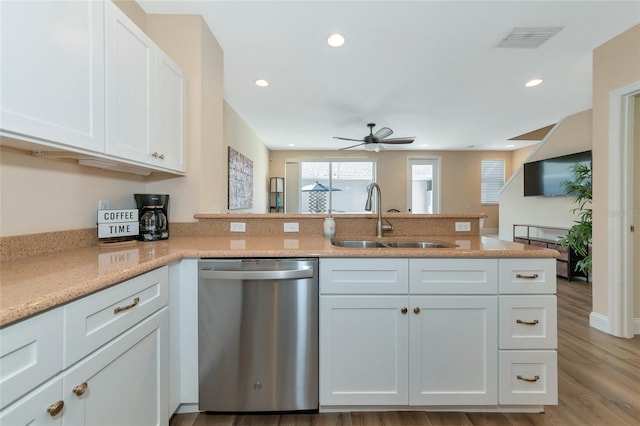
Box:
(64, 266, 169, 368)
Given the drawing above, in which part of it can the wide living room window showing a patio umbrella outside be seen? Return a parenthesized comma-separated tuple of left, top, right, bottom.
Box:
(299, 160, 375, 213)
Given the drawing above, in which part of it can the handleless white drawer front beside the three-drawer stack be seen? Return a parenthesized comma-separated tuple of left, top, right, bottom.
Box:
(409, 259, 498, 294)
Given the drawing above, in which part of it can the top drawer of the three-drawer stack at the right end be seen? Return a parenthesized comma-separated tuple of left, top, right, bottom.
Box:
(500, 259, 556, 294)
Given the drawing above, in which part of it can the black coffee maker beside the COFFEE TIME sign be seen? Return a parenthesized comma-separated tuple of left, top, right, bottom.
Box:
(133, 194, 169, 241)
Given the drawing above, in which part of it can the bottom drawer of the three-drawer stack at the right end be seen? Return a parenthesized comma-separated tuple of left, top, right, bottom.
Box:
(499, 351, 558, 405)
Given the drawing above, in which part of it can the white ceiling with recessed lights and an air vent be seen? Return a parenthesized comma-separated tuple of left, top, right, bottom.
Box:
(139, 0, 640, 150)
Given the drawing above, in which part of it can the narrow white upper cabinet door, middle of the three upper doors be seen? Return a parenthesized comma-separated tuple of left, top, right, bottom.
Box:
(105, 2, 157, 163)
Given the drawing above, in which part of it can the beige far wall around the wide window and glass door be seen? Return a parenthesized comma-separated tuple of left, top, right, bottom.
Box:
(269, 151, 511, 229)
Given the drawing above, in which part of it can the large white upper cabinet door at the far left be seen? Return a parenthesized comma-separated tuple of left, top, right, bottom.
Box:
(0, 1, 105, 152)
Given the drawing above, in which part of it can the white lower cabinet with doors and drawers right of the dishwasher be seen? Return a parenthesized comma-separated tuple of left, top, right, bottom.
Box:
(320, 259, 557, 410)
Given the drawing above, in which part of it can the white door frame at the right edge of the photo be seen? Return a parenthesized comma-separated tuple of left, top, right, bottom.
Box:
(608, 81, 640, 338)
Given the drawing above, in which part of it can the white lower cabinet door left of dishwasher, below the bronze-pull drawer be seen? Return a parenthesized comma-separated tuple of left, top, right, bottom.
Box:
(62, 308, 169, 426)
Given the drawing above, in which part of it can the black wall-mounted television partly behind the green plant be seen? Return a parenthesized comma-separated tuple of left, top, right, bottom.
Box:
(524, 151, 591, 197)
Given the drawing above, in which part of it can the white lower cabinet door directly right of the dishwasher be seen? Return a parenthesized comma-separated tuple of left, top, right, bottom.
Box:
(320, 296, 408, 407)
